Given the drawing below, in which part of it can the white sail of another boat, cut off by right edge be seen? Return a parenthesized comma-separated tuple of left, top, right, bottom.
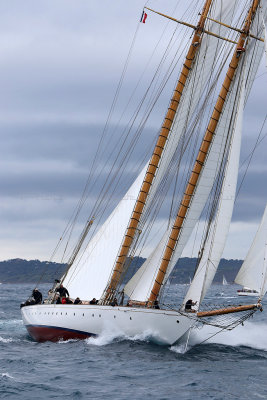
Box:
(235, 205, 267, 296)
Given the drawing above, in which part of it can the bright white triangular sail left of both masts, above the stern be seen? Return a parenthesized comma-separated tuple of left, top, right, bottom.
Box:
(64, 165, 147, 300)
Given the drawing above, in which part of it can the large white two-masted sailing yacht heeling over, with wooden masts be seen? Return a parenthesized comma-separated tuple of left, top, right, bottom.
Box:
(21, 0, 267, 345)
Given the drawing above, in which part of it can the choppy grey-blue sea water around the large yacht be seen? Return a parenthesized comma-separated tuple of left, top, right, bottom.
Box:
(0, 284, 267, 400)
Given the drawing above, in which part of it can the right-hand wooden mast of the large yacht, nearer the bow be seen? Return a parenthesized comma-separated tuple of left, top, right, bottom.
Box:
(148, 0, 259, 307)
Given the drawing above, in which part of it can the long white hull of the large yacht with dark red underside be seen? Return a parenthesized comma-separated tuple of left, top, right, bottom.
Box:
(21, 304, 195, 345)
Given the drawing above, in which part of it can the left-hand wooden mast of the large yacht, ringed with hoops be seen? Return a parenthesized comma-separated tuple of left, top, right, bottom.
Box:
(103, 0, 213, 303)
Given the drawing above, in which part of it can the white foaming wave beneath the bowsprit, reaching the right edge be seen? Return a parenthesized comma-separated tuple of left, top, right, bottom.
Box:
(192, 321, 267, 351)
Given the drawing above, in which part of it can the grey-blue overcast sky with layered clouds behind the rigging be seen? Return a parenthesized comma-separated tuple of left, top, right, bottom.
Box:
(0, 0, 267, 260)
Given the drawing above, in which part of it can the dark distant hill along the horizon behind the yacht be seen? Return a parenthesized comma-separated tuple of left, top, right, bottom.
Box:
(0, 257, 242, 283)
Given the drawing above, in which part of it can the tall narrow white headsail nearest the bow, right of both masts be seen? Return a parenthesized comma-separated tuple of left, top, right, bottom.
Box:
(183, 71, 245, 309)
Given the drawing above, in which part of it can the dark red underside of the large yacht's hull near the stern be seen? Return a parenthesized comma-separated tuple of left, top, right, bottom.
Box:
(26, 325, 96, 342)
